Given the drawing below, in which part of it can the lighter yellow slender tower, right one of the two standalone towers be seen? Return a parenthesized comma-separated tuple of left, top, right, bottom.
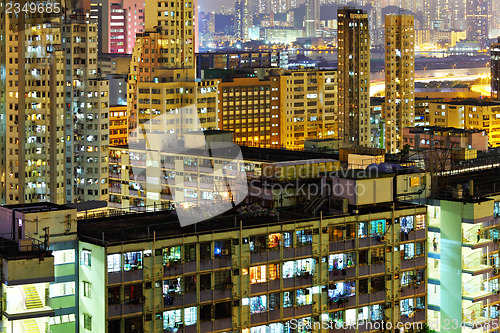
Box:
(383, 15, 415, 153)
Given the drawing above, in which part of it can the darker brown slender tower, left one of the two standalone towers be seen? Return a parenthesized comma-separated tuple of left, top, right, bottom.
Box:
(337, 8, 371, 146)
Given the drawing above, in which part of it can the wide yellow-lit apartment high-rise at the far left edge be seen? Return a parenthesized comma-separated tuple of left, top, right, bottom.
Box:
(0, 13, 66, 204)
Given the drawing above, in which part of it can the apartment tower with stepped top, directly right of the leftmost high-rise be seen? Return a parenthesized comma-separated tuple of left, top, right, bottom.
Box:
(62, 20, 109, 202)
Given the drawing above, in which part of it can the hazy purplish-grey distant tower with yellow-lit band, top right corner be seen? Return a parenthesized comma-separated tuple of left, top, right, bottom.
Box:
(466, 0, 491, 41)
